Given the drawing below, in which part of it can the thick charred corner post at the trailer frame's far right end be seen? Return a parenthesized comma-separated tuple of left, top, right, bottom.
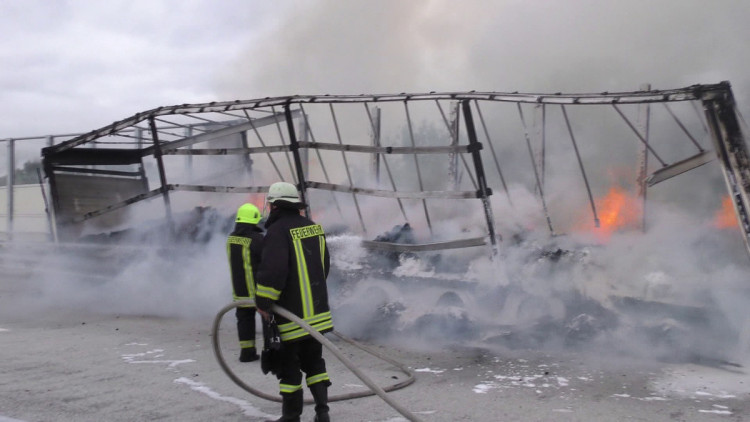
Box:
(703, 83, 750, 254)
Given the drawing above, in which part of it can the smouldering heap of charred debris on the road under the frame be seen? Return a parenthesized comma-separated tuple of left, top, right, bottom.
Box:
(333, 224, 747, 367)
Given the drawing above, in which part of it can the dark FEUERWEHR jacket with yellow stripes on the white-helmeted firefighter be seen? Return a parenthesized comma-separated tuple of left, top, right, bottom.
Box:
(256, 208, 333, 342)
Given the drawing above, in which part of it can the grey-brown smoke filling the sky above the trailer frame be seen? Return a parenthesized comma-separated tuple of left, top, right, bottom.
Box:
(214, 0, 750, 114)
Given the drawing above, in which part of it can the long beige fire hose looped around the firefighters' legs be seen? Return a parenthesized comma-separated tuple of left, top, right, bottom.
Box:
(211, 300, 421, 422)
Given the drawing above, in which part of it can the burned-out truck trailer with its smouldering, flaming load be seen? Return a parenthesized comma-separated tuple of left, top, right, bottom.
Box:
(13, 82, 750, 362)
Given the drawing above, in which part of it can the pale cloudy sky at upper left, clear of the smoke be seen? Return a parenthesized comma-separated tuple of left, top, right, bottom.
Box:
(0, 0, 282, 138)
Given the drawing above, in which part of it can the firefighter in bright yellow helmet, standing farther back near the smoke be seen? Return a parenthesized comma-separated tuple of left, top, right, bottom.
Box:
(227, 204, 263, 362)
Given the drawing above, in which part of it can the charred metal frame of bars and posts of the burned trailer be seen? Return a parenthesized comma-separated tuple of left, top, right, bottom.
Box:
(32, 82, 750, 253)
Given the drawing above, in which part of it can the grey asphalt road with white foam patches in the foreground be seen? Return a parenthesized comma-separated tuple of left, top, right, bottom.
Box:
(0, 276, 750, 422)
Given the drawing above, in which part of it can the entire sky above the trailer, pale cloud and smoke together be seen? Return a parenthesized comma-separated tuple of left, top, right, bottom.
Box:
(0, 0, 750, 138)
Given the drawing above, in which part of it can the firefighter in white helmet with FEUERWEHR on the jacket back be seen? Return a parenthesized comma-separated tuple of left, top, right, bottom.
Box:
(256, 182, 333, 422)
